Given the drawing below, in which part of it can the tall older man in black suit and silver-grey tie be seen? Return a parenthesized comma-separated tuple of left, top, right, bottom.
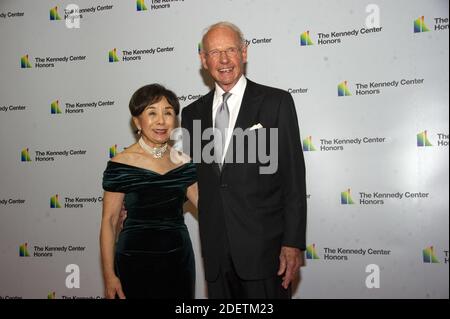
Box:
(182, 22, 306, 299)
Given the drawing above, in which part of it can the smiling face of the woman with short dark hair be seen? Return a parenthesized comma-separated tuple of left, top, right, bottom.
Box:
(133, 96, 177, 147)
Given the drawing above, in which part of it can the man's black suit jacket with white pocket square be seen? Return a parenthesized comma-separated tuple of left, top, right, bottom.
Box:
(182, 80, 306, 281)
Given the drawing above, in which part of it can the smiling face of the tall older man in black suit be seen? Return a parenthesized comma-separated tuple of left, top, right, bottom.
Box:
(200, 27, 247, 92)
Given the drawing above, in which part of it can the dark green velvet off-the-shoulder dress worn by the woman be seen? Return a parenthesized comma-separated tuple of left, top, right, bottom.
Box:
(103, 161, 197, 299)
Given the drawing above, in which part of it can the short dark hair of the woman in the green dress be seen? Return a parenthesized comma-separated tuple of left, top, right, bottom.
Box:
(129, 84, 180, 116)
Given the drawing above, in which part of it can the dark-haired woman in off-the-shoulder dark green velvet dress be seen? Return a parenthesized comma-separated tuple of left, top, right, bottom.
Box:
(100, 84, 198, 298)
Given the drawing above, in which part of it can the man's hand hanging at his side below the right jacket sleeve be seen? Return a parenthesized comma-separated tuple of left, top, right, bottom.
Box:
(278, 246, 305, 289)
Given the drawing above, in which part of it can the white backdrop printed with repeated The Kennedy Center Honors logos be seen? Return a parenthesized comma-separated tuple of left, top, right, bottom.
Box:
(0, 0, 449, 299)
